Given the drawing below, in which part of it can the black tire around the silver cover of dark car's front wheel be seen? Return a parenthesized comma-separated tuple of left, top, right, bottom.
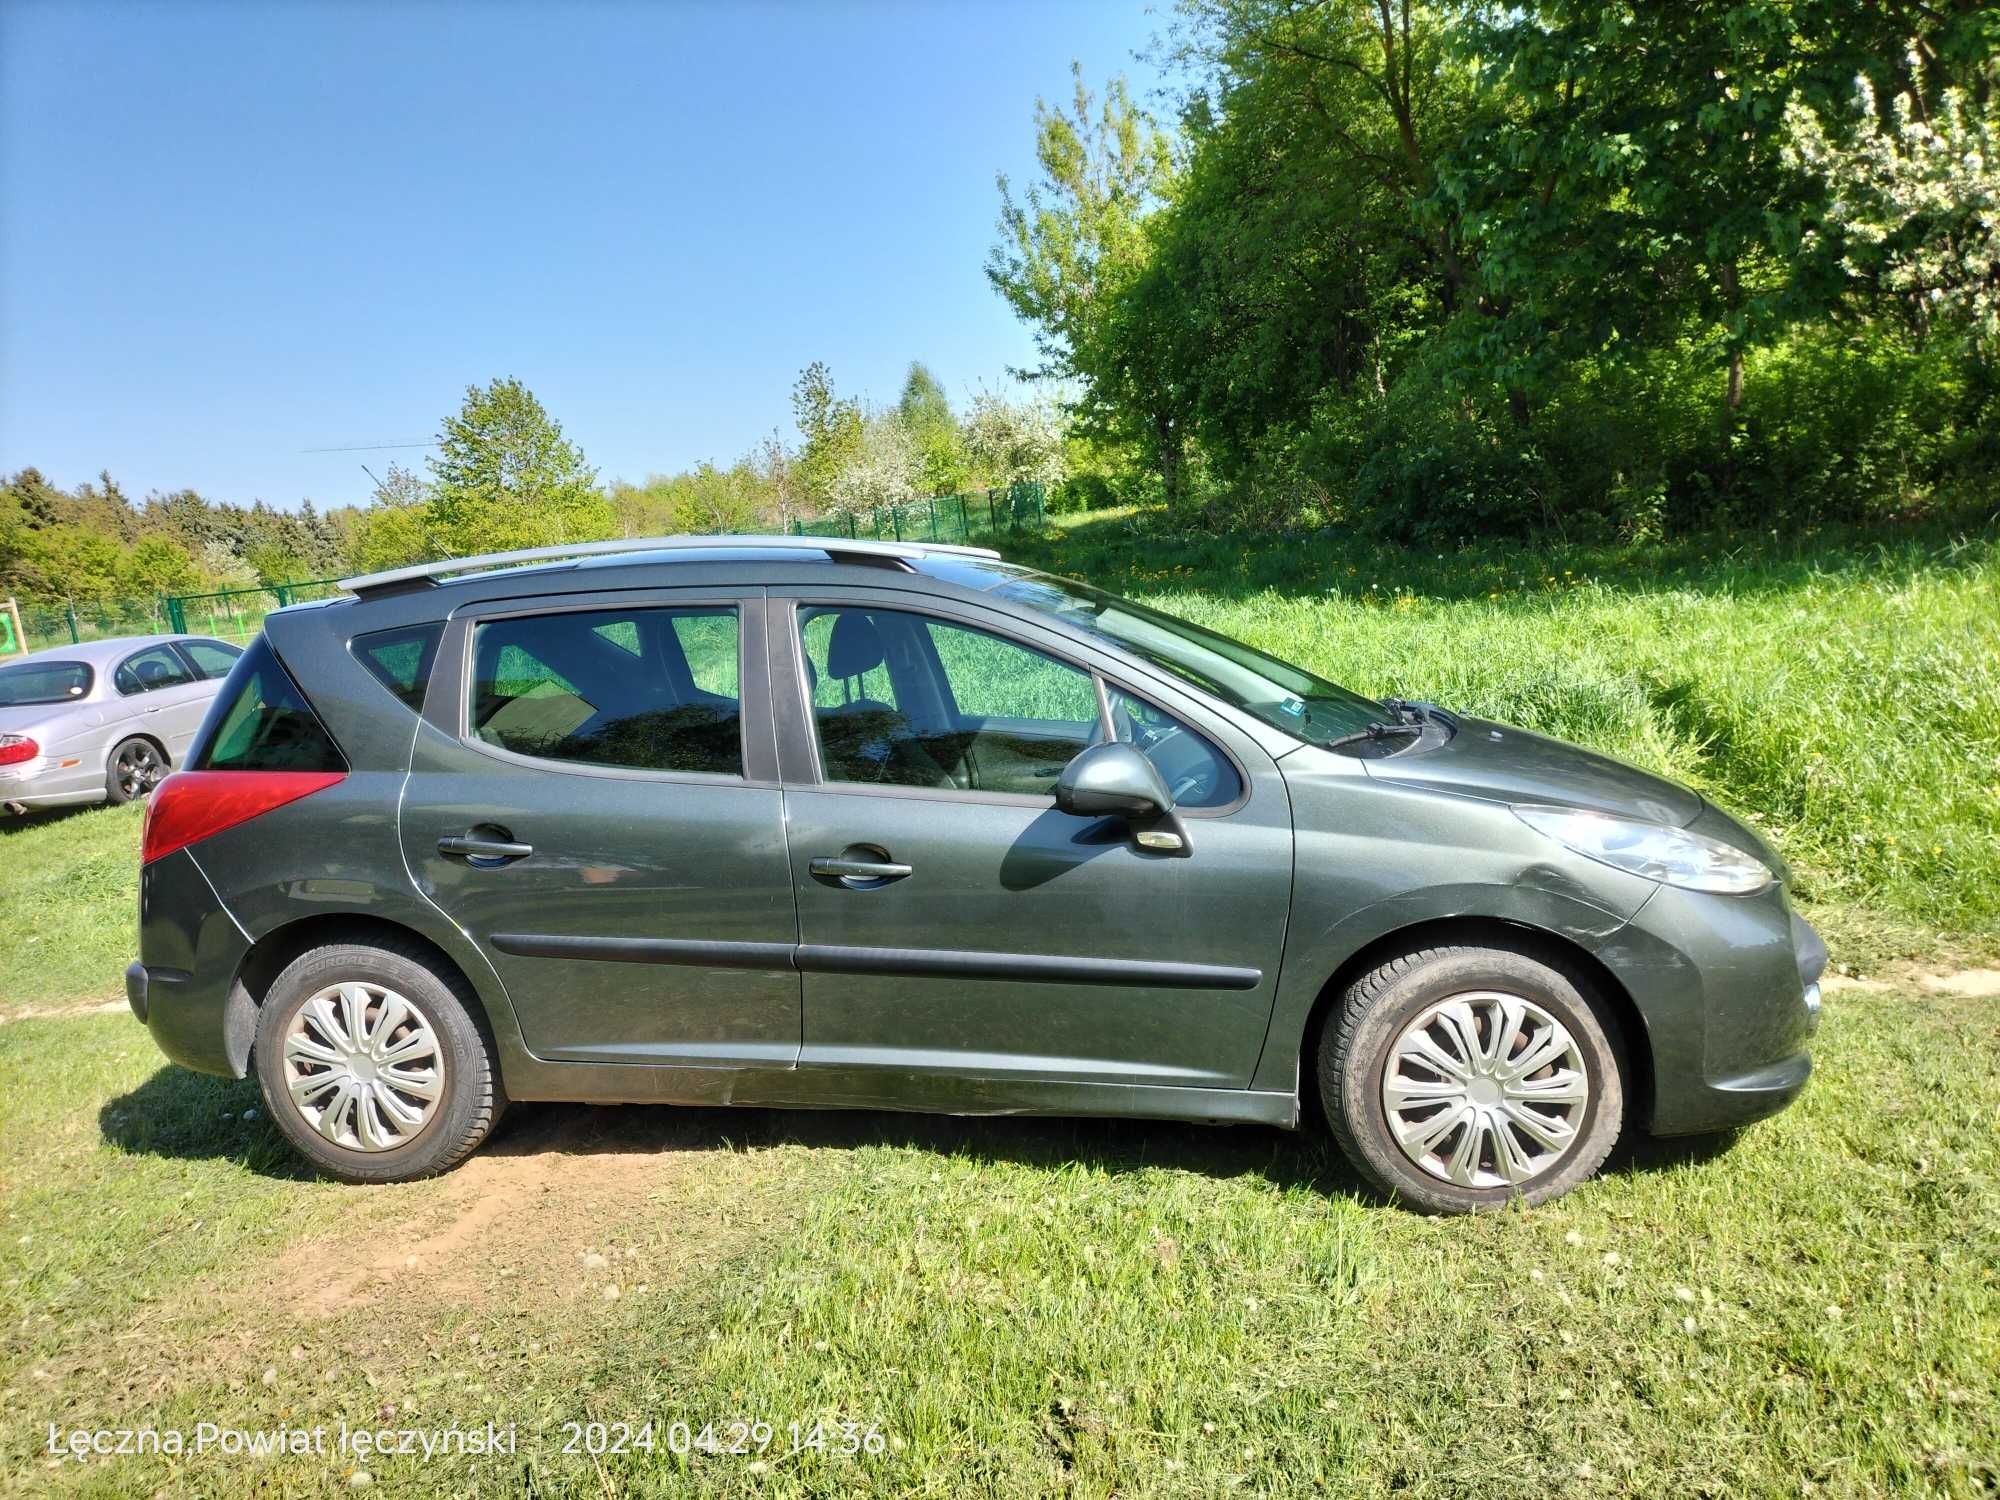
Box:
(1318, 948, 1624, 1214)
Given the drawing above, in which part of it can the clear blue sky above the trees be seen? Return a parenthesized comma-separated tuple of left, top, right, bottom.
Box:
(0, 0, 1162, 506)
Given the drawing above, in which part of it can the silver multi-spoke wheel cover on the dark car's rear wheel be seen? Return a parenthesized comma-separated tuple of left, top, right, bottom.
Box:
(284, 980, 444, 1152)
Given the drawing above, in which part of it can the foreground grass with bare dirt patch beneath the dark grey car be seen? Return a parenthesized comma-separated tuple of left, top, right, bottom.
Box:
(0, 994, 2000, 1496)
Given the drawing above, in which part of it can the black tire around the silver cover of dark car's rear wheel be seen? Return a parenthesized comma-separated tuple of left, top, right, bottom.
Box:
(254, 940, 506, 1182)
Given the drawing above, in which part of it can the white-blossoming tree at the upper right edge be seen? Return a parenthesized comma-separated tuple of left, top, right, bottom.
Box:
(1786, 56, 2000, 346)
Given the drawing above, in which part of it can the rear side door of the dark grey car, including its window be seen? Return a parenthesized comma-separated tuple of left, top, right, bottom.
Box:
(402, 590, 800, 1066)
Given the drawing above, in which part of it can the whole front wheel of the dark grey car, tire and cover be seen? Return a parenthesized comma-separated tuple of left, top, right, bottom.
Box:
(1318, 948, 1624, 1214)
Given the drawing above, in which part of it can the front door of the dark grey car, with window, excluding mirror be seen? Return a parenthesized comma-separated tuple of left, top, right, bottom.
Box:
(770, 590, 1292, 1088)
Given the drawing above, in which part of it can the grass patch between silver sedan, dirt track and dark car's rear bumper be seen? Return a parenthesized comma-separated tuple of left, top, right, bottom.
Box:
(0, 804, 144, 1016)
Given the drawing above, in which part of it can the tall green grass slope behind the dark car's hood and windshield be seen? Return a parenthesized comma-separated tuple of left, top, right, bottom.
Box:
(1012, 514, 2000, 932)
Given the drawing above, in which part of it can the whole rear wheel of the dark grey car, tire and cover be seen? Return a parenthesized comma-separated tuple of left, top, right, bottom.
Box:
(256, 944, 506, 1182)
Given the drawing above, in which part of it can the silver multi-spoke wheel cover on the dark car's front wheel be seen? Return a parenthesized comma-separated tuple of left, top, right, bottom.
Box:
(1382, 990, 1590, 1188)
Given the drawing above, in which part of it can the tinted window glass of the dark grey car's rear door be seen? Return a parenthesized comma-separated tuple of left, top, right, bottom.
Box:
(472, 608, 742, 776)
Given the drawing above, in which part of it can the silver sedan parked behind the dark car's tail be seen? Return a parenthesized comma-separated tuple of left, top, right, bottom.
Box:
(0, 636, 242, 814)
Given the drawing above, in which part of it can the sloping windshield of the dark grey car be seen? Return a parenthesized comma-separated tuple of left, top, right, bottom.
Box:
(992, 576, 1384, 744)
